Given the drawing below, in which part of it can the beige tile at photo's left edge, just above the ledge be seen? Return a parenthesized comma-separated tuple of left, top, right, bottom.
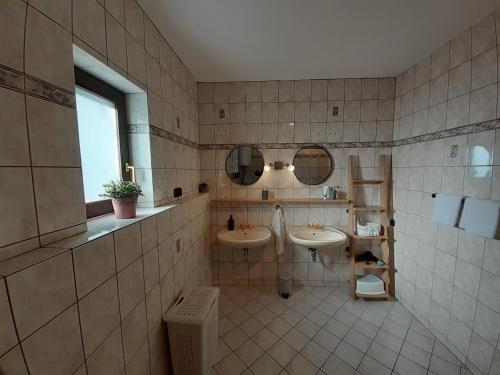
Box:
(0, 167, 38, 250)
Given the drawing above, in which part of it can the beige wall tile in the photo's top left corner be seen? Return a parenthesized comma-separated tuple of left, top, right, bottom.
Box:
(0, 0, 26, 71)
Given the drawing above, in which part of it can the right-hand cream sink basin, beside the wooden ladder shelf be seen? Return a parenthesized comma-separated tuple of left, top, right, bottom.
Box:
(288, 227, 347, 249)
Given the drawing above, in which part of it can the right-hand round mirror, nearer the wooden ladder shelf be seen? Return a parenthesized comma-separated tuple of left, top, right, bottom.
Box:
(293, 146, 334, 185)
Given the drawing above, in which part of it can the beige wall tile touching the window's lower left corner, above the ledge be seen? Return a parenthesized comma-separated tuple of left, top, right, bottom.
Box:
(33, 168, 86, 234)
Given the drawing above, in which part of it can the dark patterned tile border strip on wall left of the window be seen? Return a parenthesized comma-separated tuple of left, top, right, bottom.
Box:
(0, 65, 76, 109)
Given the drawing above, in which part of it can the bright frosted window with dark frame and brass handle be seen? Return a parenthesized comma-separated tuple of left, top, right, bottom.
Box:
(75, 68, 128, 218)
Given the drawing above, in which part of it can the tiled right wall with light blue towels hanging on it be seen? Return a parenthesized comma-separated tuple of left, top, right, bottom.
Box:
(393, 12, 500, 374)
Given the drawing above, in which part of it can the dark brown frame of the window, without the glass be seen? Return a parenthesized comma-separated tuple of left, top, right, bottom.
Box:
(75, 66, 130, 219)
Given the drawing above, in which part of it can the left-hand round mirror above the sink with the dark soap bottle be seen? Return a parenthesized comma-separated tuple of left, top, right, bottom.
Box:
(226, 146, 264, 185)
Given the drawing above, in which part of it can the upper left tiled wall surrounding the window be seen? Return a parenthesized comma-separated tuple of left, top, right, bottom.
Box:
(0, 0, 199, 259)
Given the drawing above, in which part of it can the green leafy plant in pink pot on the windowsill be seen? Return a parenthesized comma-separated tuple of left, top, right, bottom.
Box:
(100, 180, 143, 219)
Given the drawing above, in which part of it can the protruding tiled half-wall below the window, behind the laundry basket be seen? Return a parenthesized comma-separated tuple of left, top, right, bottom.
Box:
(0, 195, 211, 375)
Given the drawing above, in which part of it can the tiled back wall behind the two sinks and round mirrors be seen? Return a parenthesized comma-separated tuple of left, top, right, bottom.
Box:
(198, 78, 395, 285)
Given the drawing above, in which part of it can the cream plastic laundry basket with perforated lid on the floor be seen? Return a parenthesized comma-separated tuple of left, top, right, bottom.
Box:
(165, 287, 219, 375)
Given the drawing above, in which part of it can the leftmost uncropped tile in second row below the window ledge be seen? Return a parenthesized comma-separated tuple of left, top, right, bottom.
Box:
(78, 277, 120, 358)
